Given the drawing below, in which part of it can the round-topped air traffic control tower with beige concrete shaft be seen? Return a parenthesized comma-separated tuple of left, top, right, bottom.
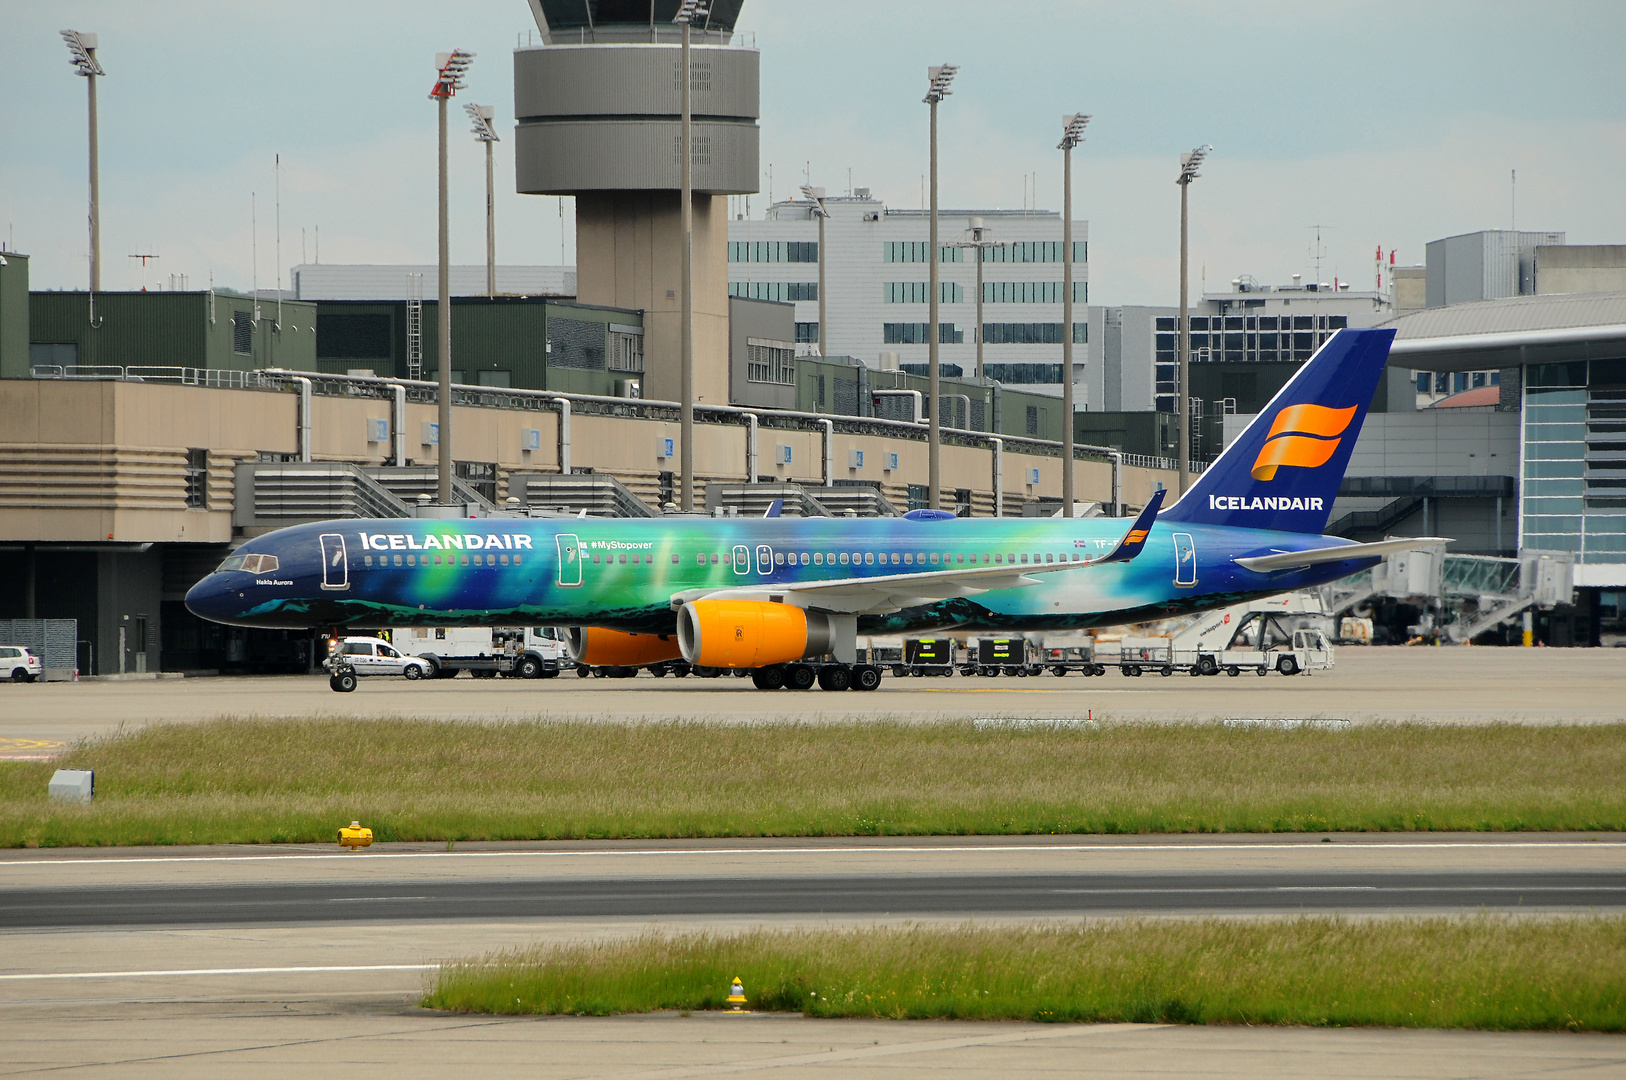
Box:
(514, 0, 761, 405)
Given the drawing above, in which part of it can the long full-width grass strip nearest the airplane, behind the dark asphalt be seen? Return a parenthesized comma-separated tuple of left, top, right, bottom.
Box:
(0, 719, 1626, 846)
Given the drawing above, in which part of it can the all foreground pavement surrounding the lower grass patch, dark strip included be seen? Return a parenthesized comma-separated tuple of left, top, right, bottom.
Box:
(0, 834, 1626, 1080)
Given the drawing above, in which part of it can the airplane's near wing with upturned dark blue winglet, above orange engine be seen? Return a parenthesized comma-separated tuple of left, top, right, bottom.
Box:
(672, 491, 1163, 615)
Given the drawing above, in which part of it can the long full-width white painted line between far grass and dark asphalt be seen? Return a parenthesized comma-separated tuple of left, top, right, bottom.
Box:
(0, 841, 1626, 869)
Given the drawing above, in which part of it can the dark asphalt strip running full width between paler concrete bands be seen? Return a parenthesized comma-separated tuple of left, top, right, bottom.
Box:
(0, 870, 1626, 929)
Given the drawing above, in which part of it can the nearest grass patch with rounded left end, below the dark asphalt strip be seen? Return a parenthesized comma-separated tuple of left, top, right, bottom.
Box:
(421, 916, 1626, 1031)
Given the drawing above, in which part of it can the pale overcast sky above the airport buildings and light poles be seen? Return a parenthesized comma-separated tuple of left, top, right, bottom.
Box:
(0, 0, 1626, 304)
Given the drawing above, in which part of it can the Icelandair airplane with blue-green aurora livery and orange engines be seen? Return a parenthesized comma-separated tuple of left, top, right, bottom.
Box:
(187, 330, 1442, 686)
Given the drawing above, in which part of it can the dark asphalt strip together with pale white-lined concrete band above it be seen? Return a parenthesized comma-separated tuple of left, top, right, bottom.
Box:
(0, 836, 1626, 930)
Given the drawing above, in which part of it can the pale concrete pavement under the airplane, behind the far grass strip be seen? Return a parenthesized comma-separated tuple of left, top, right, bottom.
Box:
(0, 647, 1626, 758)
